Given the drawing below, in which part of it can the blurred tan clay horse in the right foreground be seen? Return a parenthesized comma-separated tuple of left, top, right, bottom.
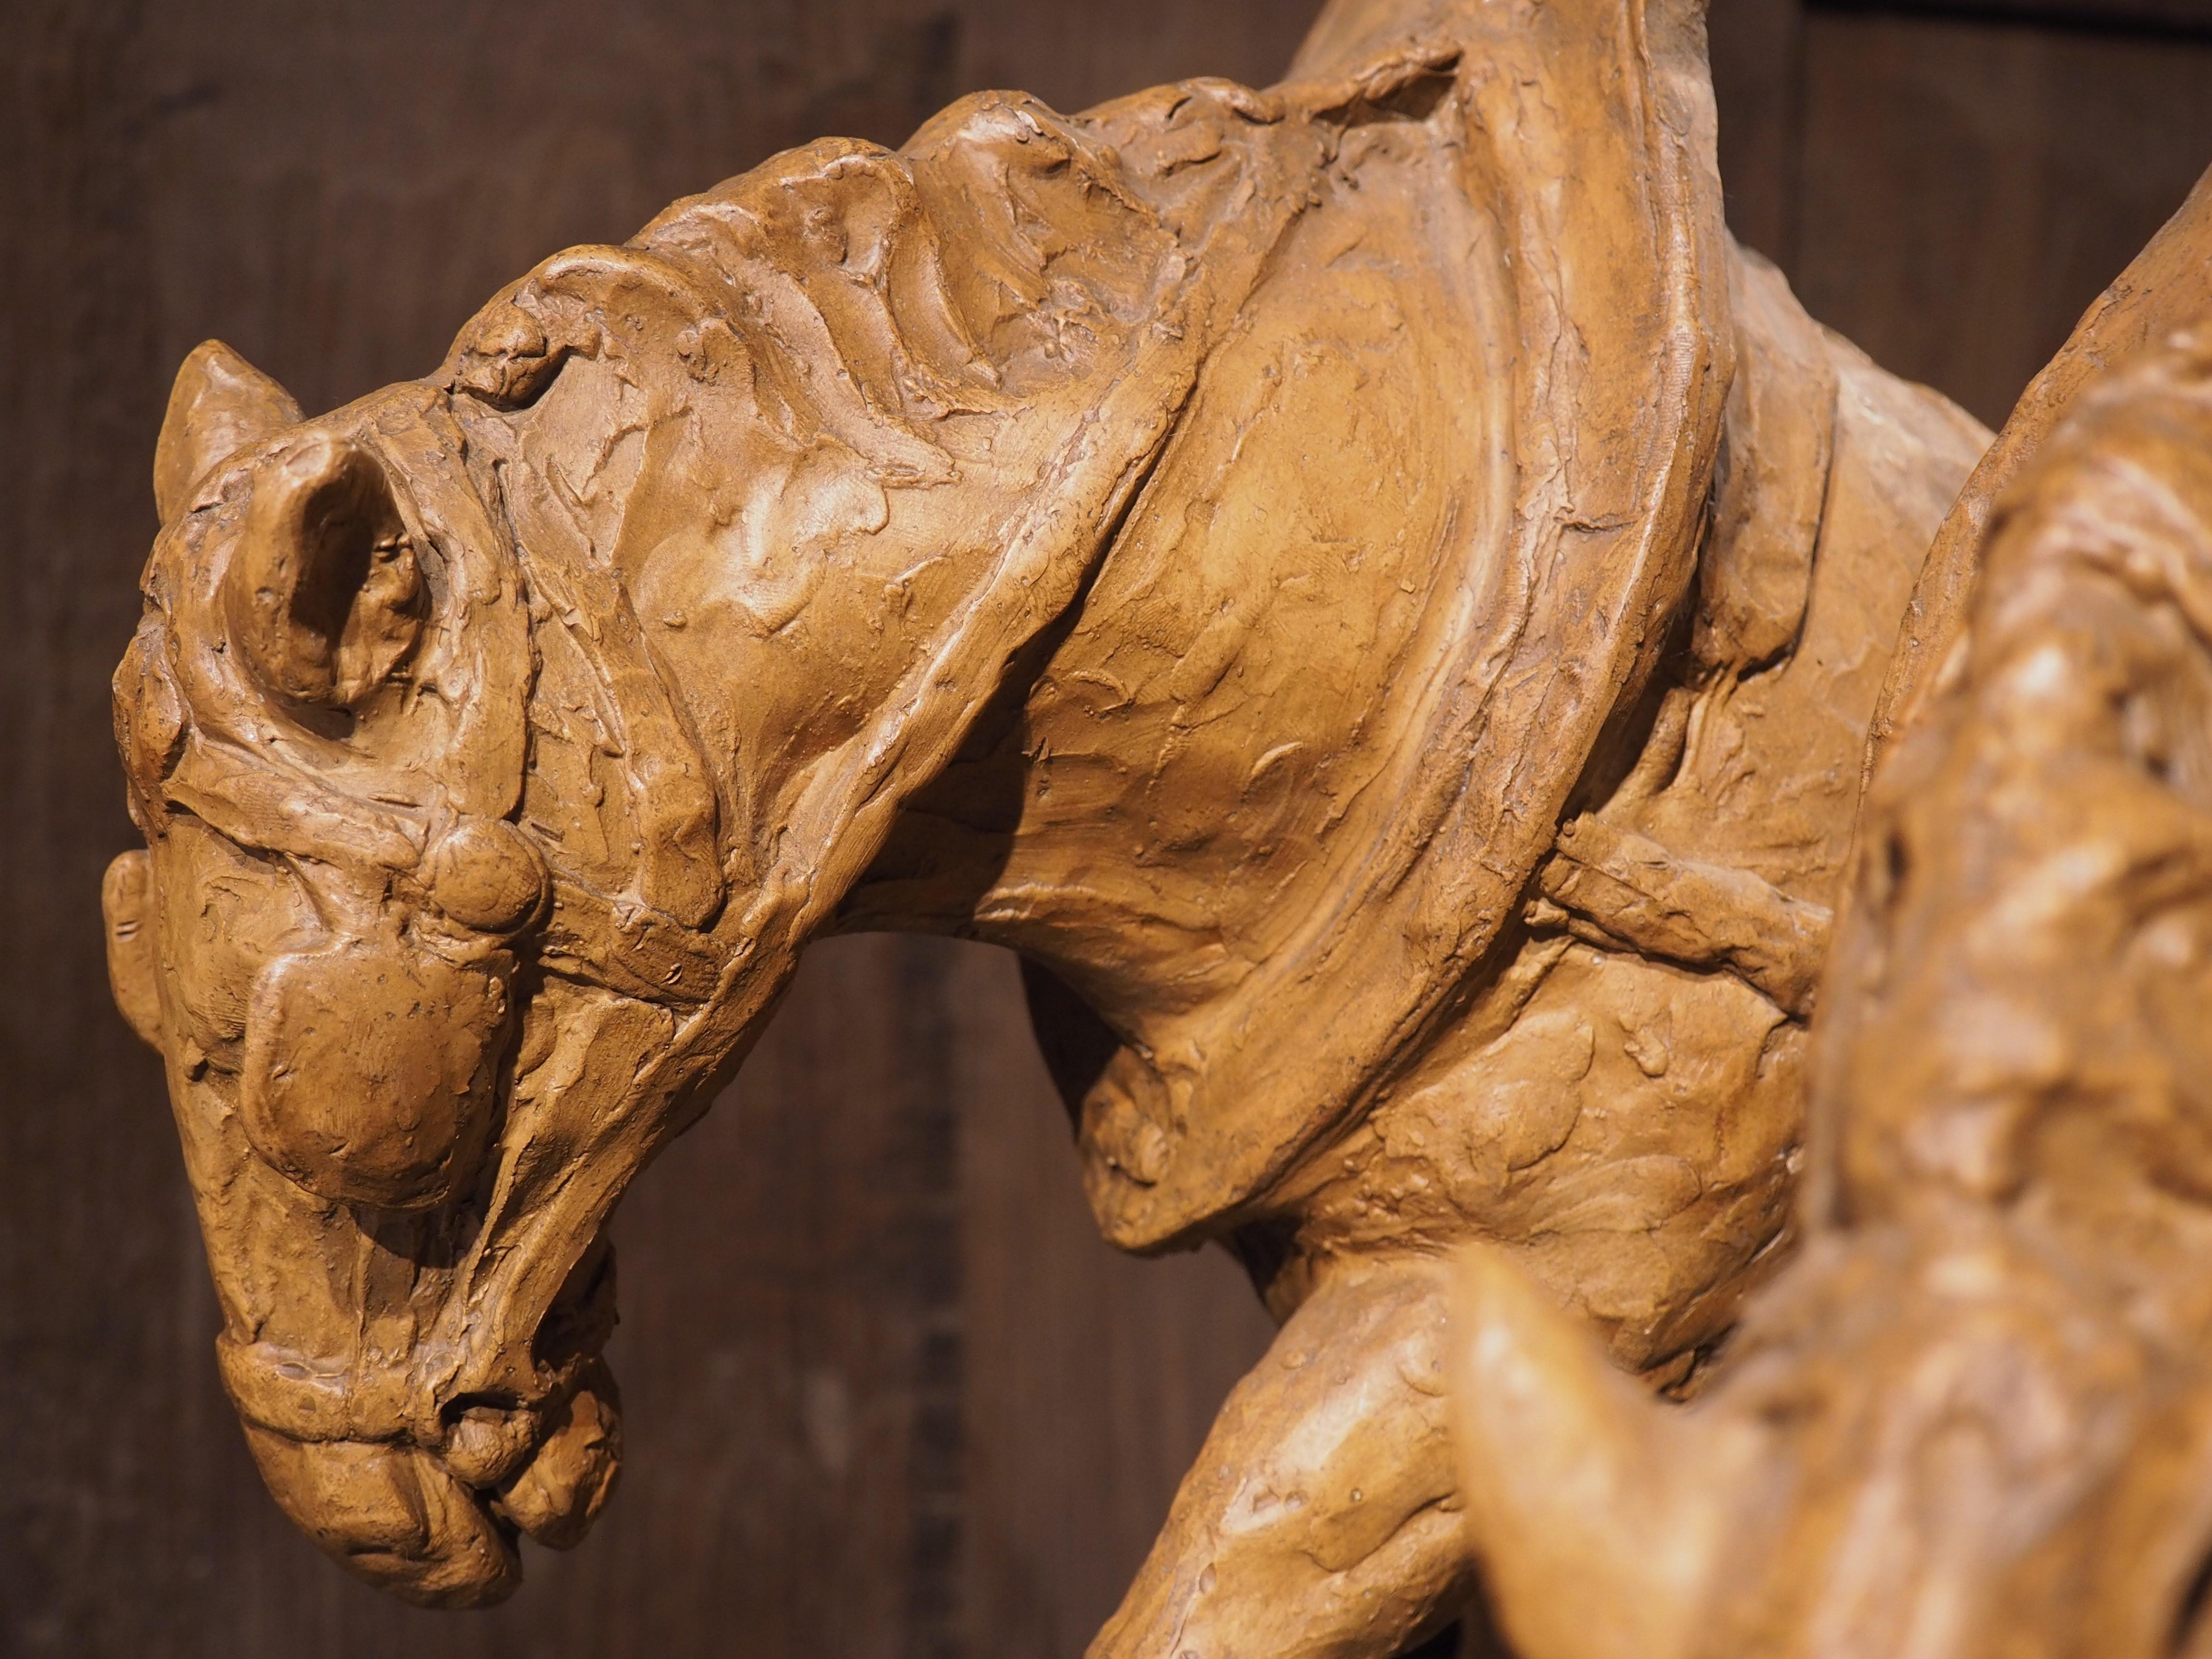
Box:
(1453, 183, 2212, 1659)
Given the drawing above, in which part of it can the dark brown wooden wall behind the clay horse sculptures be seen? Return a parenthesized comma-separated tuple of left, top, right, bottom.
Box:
(0, 0, 2212, 1659)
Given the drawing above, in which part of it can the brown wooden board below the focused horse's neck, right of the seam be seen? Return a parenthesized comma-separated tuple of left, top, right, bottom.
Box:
(949, 945, 1274, 1659)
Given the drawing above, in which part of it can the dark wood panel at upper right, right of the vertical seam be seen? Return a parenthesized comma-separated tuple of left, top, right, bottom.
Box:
(1787, 11, 2212, 425)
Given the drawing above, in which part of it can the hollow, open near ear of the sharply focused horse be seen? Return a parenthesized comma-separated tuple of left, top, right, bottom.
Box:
(223, 432, 427, 708)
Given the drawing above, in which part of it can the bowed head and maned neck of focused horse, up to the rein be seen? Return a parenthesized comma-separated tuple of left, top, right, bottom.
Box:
(106, 84, 1380, 1604)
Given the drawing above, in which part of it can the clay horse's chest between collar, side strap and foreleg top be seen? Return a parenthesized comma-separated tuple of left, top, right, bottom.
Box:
(1285, 938, 1803, 1369)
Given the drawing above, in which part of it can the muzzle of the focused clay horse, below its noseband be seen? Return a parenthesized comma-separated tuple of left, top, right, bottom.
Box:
(245, 1360, 622, 1608)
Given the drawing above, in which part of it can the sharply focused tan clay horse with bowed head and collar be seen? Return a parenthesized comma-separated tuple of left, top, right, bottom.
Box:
(108, 0, 1986, 1659)
